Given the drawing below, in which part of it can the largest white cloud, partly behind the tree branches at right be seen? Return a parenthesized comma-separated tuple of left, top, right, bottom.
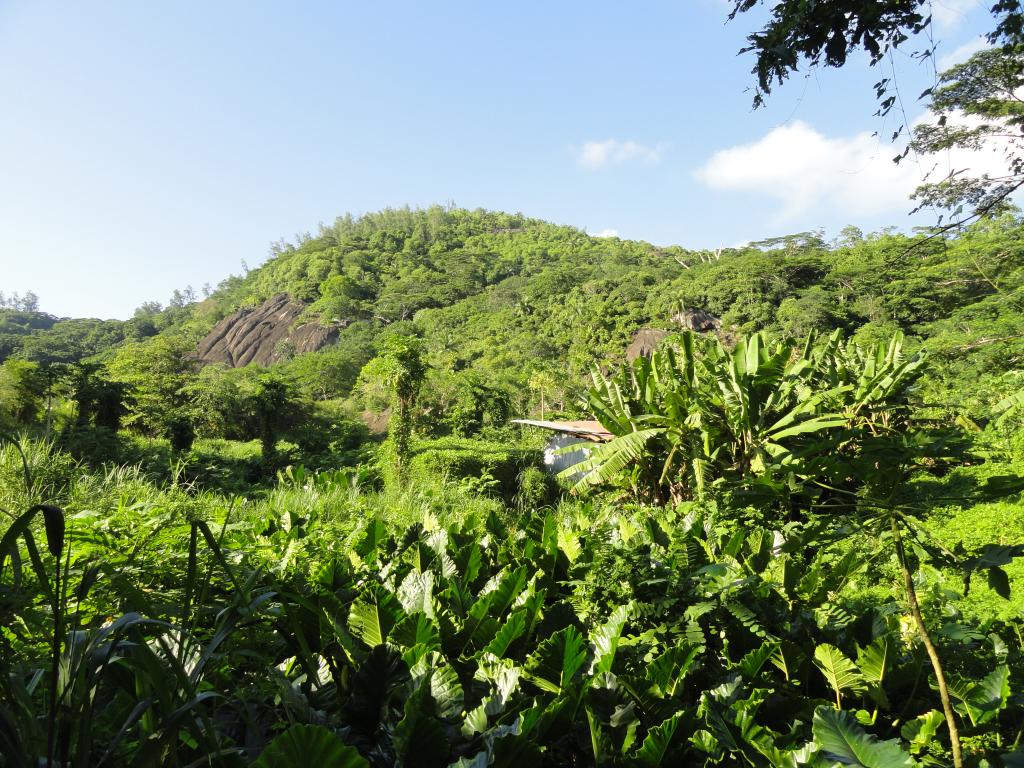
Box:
(694, 115, 1006, 222)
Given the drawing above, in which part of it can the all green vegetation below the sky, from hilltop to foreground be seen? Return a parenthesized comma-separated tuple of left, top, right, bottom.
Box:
(0, 207, 1024, 768)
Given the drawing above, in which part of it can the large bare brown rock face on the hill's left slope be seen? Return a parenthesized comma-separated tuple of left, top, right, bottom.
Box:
(196, 293, 339, 368)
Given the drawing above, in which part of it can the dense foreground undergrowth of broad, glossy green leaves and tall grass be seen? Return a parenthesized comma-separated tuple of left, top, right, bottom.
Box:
(0, 430, 1024, 768)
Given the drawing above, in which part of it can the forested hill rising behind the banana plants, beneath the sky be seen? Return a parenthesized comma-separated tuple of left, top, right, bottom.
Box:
(0, 207, 1024, 434)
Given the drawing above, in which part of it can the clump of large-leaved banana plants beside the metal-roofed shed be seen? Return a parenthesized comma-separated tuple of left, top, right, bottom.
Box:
(563, 332, 924, 511)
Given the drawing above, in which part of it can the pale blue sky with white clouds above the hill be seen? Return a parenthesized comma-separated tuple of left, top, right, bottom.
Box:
(0, 0, 991, 317)
